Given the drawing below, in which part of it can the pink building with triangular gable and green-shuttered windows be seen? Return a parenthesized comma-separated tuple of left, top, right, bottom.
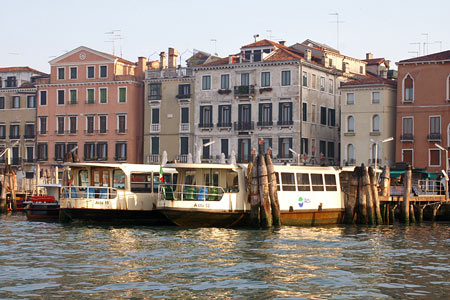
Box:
(36, 46, 146, 163)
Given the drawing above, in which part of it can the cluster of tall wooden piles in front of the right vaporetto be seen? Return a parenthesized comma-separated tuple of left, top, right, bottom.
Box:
(247, 149, 281, 228)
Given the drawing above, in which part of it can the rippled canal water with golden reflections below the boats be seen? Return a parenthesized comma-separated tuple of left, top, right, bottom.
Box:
(0, 215, 450, 299)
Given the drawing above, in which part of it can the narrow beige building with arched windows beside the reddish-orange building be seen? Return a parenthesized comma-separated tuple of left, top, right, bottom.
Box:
(340, 77, 397, 165)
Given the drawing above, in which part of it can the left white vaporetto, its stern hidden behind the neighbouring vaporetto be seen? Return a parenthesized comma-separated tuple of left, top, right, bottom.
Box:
(60, 163, 177, 225)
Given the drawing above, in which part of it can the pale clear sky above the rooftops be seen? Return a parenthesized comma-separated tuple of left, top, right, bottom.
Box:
(0, 0, 450, 73)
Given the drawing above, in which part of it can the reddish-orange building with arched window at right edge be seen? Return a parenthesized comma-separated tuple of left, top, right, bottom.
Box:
(396, 50, 450, 172)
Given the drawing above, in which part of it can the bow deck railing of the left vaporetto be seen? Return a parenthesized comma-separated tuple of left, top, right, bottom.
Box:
(61, 185, 117, 199)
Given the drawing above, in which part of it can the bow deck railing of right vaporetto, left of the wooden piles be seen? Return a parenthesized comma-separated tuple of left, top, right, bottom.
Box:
(159, 184, 225, 201)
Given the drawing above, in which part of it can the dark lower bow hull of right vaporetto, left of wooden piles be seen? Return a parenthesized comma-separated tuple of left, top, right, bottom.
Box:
(161, 209, 248, 227)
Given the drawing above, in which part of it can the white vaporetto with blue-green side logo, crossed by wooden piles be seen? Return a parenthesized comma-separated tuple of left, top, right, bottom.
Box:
(157, 163, 344, 227)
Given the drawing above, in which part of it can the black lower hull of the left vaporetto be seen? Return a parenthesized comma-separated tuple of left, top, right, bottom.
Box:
(59, 208, 172, 225)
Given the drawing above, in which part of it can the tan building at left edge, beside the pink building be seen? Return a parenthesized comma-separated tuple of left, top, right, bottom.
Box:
(0, 67, 47, 186)
